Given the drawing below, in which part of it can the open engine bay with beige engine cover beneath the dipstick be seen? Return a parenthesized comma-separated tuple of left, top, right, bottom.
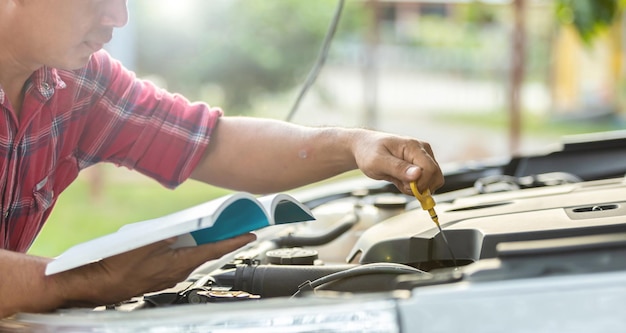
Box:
(109, 170, 626, 311)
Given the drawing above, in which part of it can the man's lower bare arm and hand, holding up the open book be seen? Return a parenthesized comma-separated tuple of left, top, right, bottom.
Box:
(0, 234, 255, 319)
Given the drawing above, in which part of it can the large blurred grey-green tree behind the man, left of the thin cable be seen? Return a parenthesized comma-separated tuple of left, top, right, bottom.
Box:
(138, 0, 362, 113)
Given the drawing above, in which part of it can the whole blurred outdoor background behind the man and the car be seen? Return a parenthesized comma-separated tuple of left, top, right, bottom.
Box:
(29, 0, 626, 256)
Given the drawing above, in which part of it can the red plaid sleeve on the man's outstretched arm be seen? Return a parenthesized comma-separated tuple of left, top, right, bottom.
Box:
(74, 52, 223, 188)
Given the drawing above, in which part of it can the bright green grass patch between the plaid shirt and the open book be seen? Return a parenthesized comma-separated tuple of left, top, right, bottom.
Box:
(28, 166, 228, 257)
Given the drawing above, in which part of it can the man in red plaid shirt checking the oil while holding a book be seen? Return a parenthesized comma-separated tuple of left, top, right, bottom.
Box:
(0, 0, 443, 318)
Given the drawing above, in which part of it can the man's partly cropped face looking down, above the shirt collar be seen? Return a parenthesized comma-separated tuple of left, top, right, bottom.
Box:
(13, 0, 128, 69)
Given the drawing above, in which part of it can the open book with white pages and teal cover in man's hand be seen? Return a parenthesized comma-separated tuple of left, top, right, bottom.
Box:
(45, 192, 315, 275)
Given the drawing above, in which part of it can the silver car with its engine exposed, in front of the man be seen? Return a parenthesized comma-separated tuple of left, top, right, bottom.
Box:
(0, 131, 626, 333)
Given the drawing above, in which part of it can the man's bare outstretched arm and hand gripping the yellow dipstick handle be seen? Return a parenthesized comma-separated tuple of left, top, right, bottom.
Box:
(191, 117, 443, 195)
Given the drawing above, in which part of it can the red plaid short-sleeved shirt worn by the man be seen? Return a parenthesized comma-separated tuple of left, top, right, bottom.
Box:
(0, 51, 222, 252)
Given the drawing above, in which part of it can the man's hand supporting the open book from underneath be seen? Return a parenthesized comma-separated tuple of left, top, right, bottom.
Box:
(52, 234, 256, 306)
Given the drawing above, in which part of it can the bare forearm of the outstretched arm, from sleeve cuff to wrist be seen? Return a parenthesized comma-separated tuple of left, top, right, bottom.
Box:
(192, 117, 360, 193)
